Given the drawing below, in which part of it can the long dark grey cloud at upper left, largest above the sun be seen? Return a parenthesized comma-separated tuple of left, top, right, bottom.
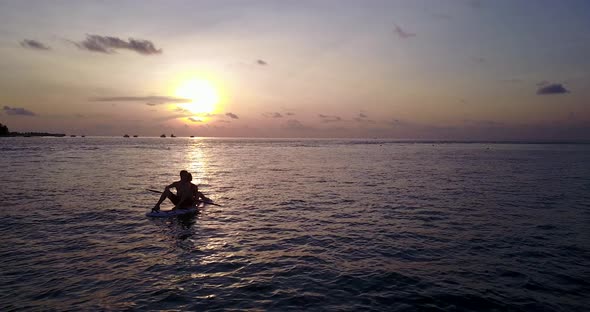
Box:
(73, 35, 162, 55)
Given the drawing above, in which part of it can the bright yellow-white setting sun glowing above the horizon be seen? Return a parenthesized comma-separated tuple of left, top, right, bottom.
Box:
(174, 79, 219, 114)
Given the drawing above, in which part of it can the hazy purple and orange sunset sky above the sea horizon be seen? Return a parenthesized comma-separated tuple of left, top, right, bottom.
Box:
(0, 0, 590, 140)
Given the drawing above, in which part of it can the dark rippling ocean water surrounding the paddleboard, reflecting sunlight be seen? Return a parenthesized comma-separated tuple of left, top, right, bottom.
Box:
(0, 137, 590, 311)
